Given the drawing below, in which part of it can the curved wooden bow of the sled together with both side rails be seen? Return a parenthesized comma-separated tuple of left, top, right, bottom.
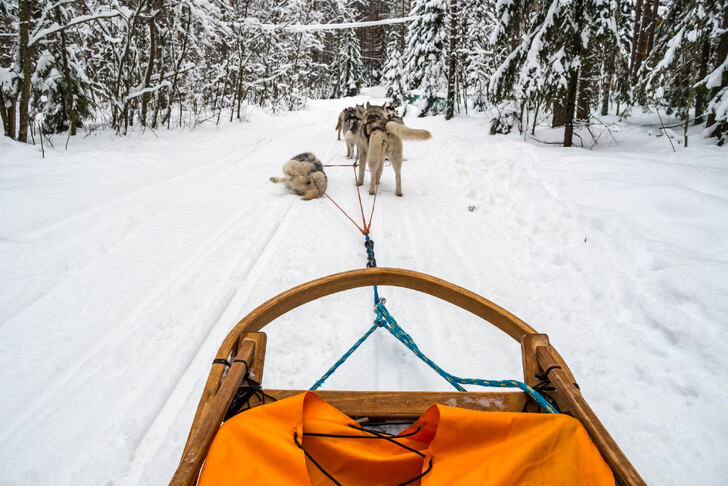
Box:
(170, 268, 645, 485)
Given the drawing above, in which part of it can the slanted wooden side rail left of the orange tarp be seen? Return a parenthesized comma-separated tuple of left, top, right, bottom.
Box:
(170, 339, 256, 486)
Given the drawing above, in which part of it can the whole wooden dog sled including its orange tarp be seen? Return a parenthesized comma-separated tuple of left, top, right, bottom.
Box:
(170, 268, 645, 486)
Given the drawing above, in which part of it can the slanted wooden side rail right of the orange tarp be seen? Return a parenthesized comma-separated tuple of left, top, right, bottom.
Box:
(536, 346, 647, 486)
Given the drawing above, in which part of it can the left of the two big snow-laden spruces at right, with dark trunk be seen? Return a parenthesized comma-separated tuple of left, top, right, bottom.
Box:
(490, 0, 617, 147)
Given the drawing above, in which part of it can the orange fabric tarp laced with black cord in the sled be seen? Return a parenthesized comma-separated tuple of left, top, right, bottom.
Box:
(199, 392, 614, 486)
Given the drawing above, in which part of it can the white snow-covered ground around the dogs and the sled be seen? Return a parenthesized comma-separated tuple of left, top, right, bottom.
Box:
(0, 88, 728, 485)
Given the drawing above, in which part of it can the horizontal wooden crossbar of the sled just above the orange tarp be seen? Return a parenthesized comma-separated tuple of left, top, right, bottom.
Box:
(251, 390, 528, 420)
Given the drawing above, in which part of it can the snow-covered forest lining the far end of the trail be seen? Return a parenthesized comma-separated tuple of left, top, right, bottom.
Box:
(0, 0, 728, 146)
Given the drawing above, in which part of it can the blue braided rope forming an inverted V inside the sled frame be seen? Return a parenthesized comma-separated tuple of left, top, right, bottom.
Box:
(311, 302, 558, 413)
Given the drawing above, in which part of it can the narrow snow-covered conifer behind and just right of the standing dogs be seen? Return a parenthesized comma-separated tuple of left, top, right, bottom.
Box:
(403, 0, 449, 116)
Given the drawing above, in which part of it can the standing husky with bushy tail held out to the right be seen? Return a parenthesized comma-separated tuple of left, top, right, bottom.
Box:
(356, 103, 432, 196)
